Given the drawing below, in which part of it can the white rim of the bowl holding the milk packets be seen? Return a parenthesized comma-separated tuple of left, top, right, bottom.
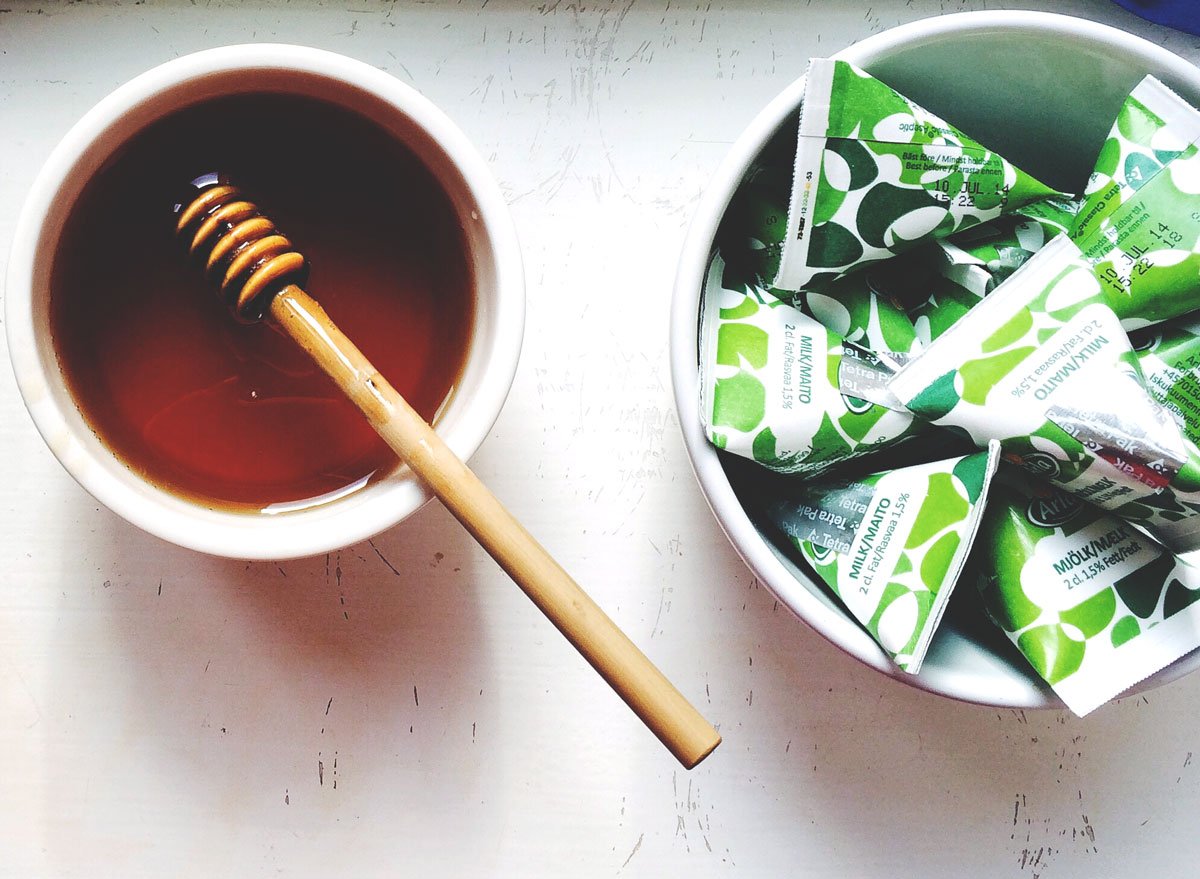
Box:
(670, 11, 1200, 708)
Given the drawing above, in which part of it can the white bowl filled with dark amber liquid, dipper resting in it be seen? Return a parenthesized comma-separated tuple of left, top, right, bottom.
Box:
(5, 46, 524, 558)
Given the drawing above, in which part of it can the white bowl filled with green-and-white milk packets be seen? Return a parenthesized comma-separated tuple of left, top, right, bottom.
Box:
(671, 12, 1200, 714)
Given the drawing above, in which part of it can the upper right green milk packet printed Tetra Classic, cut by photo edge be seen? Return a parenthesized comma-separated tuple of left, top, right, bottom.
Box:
(1072, 77, 1200, 329)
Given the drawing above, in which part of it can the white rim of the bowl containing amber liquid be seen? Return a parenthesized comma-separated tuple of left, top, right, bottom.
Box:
(5, 43, 526, 560)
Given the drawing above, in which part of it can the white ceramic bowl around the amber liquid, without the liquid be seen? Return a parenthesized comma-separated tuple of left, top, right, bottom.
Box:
(5, 44, 524, 558)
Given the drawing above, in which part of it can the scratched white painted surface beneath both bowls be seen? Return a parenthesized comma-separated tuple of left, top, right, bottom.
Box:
(0, 0, 1200, 879)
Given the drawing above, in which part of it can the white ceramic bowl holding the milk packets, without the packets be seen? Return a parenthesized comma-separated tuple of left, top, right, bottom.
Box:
(671, 12, 1200, 707)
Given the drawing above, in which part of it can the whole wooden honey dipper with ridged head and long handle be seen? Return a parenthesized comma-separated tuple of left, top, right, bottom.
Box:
(175, 174, 721, 769)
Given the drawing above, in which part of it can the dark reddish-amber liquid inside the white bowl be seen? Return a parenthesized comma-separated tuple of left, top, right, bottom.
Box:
(50, 94, 474, 510)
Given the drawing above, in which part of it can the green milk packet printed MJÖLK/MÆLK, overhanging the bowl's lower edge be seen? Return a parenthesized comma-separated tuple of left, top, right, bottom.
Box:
(976, 467, 1200, 716)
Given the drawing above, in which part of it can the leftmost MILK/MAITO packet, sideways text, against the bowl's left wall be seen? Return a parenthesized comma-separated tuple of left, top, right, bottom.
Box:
(700, 257, 924, 473)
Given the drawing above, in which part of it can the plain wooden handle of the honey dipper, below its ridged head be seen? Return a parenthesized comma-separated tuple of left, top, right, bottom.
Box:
(270, 285, 721, 769)
